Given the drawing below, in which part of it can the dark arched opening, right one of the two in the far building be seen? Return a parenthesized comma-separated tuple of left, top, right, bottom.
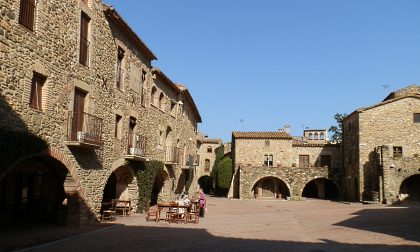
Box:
(302, 178, 338, 200)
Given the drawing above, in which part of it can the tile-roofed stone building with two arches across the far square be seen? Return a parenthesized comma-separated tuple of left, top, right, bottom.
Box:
(229, 130, 341, 199)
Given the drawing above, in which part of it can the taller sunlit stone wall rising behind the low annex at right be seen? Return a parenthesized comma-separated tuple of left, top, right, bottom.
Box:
(343, 97, 420, 200)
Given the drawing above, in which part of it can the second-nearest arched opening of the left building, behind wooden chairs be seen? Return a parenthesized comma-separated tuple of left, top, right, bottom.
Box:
(102, 166, 134, 202)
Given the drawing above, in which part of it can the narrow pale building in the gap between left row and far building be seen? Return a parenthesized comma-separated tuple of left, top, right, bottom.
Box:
(197, 136, 222, 193)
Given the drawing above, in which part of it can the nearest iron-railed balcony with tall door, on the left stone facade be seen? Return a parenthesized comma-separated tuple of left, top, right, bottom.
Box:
(66, 111, 103, 148)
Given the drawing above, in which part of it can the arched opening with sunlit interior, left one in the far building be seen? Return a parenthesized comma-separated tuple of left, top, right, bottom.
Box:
(252, 177, 290, 199)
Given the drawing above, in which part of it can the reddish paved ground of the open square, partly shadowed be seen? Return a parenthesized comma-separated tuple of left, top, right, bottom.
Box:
(4, 197, 420, 252)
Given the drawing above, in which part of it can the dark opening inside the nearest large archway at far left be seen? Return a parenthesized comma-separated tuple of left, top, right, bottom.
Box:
(0, 155, 69, 227)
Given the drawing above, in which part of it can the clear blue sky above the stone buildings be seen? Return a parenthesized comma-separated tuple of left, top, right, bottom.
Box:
(104, 0, 420, 141)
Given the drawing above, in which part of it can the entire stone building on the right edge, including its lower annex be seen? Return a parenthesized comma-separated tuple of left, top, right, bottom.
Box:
(343, 85, 420, 203)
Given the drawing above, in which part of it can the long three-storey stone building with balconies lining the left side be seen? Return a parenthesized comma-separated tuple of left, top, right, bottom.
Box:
(0, 0, 201, 225)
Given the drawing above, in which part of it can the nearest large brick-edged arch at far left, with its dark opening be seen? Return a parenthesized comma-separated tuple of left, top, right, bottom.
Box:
(0, 147, 85, 226)
